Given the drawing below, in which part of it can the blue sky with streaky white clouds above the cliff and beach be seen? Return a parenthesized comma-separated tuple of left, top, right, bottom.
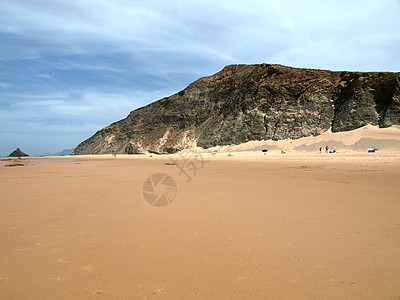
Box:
(0, 0, 400, 156)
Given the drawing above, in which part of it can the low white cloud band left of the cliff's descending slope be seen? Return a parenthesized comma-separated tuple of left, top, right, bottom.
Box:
(0, 91, 172, 127)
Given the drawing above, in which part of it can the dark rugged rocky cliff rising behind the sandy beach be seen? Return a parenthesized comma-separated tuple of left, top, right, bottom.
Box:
(74, 64, 400, 154)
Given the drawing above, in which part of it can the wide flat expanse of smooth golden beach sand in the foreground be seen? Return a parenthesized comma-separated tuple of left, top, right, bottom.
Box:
(0, 152, 400, 299)
